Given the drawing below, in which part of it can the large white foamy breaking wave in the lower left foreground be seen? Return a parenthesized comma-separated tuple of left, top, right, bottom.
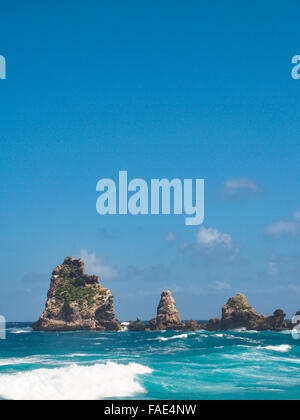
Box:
(0, 362, 152, 400)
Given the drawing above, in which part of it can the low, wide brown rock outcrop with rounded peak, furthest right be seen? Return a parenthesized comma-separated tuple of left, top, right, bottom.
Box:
(201, 294, 290, 331)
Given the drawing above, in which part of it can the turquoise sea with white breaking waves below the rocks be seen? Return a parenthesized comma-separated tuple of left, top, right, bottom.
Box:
(0, 325, 300, 400)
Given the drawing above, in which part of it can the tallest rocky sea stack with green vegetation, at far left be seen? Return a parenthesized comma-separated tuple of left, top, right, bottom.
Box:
(32, 257, 121, 331)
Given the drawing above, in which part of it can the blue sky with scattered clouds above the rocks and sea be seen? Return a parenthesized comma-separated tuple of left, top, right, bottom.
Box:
(0, 0, 300, 321)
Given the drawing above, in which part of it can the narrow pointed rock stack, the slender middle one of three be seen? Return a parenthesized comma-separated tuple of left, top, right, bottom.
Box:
(150, 290, 198, 331)
